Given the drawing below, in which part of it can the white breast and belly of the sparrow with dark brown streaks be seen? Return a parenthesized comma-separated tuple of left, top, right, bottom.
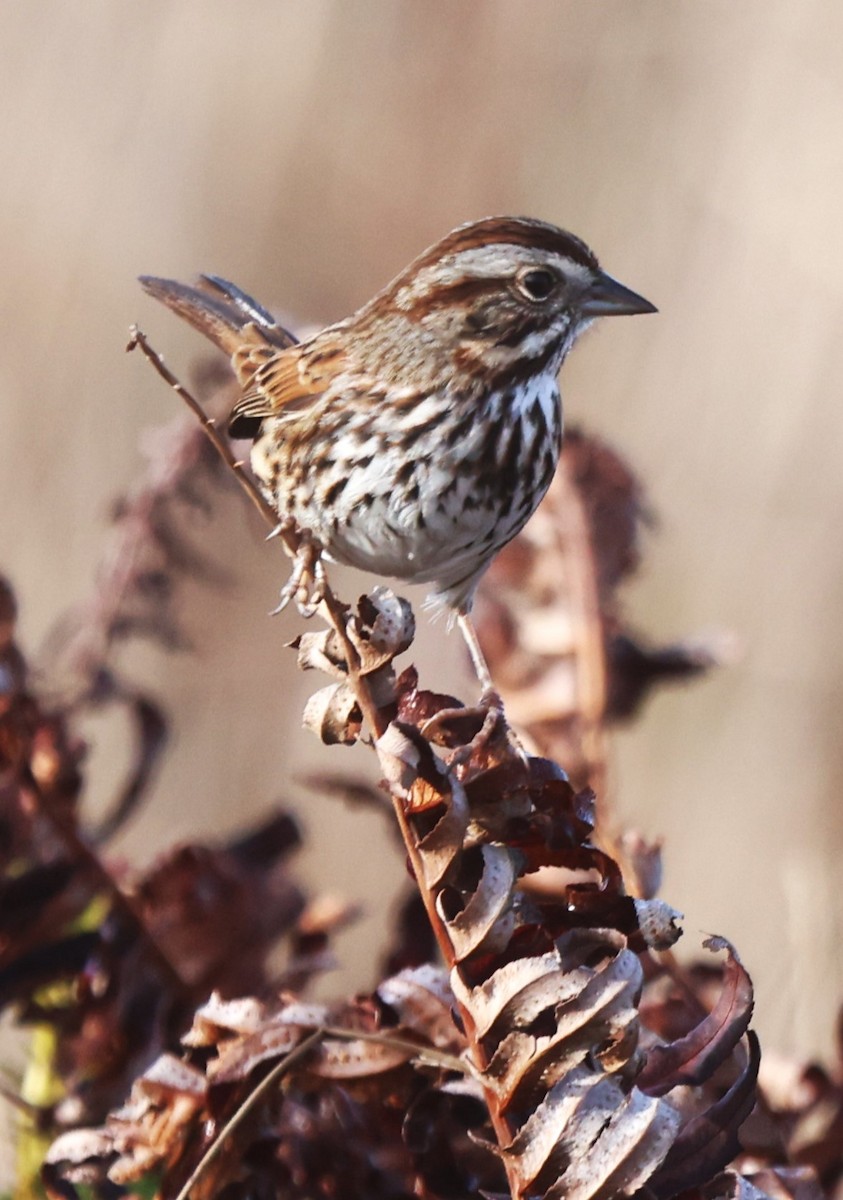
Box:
(252, 376, 562, 582)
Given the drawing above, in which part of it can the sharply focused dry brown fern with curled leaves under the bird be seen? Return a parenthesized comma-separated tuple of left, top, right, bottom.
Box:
(39, 334, 778, 1200)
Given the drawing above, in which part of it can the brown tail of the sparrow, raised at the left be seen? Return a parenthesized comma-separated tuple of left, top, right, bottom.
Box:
(139, 275, 295, 356)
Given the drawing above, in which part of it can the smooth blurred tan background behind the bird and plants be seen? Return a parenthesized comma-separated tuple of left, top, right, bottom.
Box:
(0, 0, 843, 1052)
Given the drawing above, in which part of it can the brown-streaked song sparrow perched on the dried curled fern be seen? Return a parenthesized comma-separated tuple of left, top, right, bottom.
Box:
(141, 217, 656, 691)
